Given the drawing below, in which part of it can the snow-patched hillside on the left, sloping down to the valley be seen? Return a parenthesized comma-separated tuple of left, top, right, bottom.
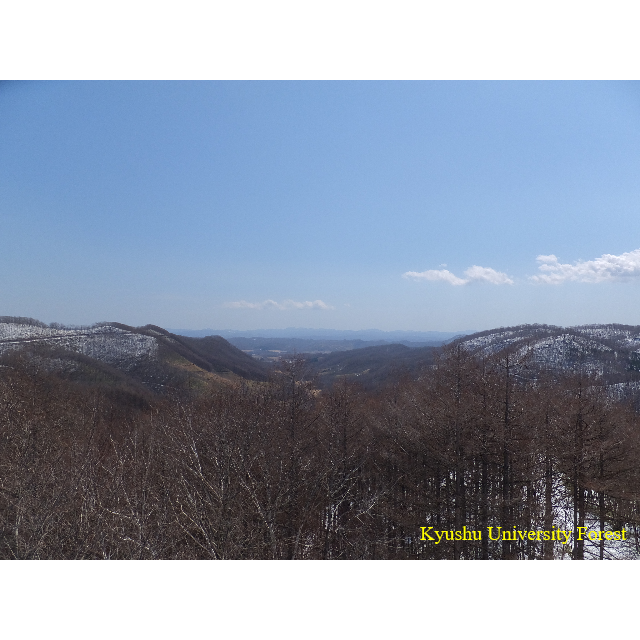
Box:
(0, 316, 267, 394)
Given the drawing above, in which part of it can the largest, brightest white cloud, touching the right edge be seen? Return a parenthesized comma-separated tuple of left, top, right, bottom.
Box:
(531, 249, 640, 284)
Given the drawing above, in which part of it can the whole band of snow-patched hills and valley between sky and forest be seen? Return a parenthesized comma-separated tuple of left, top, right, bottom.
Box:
(0, 316, 640, 394)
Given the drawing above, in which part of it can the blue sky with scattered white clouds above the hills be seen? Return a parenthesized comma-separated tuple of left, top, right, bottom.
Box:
(0, 82, 640, 331)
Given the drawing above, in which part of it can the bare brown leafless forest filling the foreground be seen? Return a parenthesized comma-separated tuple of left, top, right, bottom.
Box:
(0, 344, 640, 560)
